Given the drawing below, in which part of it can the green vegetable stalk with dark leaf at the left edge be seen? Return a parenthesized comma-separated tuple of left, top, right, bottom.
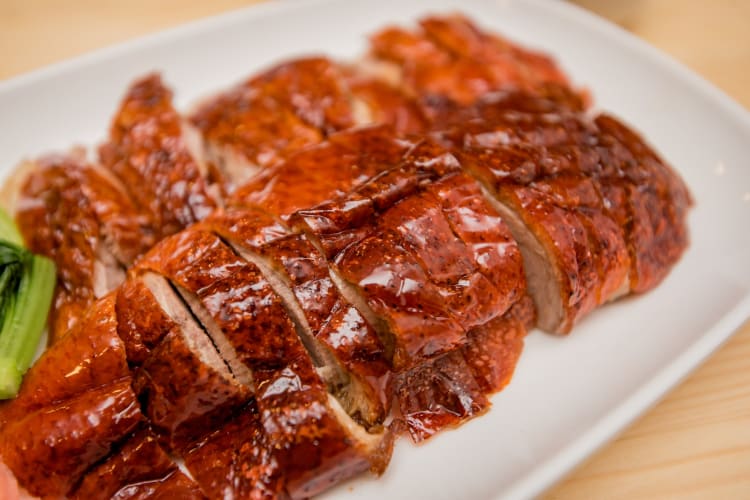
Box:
(0, 209, 56, 399)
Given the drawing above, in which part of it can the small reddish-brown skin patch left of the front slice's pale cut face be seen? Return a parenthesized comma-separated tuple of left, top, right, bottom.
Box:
(115, 276, 178, 366)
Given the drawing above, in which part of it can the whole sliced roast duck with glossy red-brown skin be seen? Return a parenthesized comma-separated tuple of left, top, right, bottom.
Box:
(0, 16, 691, 498)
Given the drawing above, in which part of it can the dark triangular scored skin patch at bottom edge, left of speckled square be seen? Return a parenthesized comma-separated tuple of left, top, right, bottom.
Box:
(69, 428, 205, 500)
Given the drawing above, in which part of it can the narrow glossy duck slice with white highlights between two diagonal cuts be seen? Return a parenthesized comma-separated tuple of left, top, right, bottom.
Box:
(201, 210, 391, 426)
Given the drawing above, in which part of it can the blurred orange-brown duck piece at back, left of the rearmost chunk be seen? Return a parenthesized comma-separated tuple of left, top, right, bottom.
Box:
(190, 57, 427, 193)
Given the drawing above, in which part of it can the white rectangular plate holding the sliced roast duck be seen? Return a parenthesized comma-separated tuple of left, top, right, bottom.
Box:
(0, 0, 750, 499)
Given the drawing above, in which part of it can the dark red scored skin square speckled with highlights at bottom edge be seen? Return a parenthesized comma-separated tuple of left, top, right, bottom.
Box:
(185, 403, 287, 499)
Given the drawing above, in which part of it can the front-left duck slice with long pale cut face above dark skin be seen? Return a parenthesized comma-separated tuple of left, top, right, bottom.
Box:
(120, 272, 252, 450)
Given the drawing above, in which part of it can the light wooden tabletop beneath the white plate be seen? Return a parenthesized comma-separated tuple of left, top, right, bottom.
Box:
(0, 0, 750, 499)
